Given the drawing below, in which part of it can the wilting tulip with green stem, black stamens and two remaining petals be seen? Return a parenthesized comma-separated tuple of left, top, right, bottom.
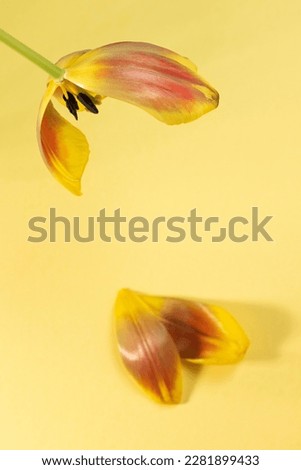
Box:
(0, 30, 219, 195)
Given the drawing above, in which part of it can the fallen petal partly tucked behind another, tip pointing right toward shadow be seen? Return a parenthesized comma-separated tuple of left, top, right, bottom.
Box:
(120, 294, 249, 364)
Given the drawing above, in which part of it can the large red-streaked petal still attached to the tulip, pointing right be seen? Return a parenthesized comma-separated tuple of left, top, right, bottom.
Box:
(65, 42, 219, 124)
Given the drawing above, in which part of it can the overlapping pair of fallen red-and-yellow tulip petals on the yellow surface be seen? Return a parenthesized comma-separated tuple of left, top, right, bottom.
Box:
(114, 289, 249, 403)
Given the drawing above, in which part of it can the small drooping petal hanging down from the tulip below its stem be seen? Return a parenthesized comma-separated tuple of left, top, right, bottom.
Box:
(37, 82, 89, 195)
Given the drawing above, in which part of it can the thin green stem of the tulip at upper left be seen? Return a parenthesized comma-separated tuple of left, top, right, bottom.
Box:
(0, 28, 64, 79)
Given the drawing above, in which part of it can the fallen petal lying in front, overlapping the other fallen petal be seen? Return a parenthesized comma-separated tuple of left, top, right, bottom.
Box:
(115, 289, 182, 403)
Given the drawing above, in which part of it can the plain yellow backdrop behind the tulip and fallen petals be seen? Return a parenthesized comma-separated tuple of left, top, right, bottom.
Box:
(0, 0, 301, 449)
